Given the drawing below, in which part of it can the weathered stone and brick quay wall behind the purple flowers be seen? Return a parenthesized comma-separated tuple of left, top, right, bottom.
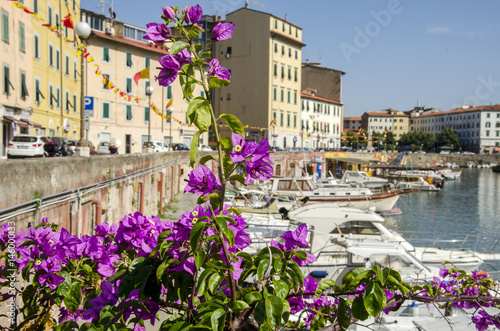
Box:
(0, 151, 311, 235)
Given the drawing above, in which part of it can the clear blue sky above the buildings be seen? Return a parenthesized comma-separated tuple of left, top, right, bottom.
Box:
(82, 0, 500, 116)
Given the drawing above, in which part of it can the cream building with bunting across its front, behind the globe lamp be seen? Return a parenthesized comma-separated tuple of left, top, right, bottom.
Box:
(82, 10, 208, 153)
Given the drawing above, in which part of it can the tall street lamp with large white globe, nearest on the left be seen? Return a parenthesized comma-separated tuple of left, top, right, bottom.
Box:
(75, 21, 92, 157)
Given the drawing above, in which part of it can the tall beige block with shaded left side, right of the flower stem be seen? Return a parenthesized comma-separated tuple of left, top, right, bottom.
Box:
(212, 6, 305, 148)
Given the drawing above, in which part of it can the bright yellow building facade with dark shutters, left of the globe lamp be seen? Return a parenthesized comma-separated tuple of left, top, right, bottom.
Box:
(30, 0, 81, 140)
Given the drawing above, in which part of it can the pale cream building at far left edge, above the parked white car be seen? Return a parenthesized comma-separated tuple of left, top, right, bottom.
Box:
(0, 1, 34, 157)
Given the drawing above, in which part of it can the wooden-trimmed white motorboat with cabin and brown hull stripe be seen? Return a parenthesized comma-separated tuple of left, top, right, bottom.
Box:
(271, 177, 400, 211)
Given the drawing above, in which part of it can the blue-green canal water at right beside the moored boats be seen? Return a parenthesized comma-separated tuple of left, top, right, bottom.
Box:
(387, 168, 500, 276)
